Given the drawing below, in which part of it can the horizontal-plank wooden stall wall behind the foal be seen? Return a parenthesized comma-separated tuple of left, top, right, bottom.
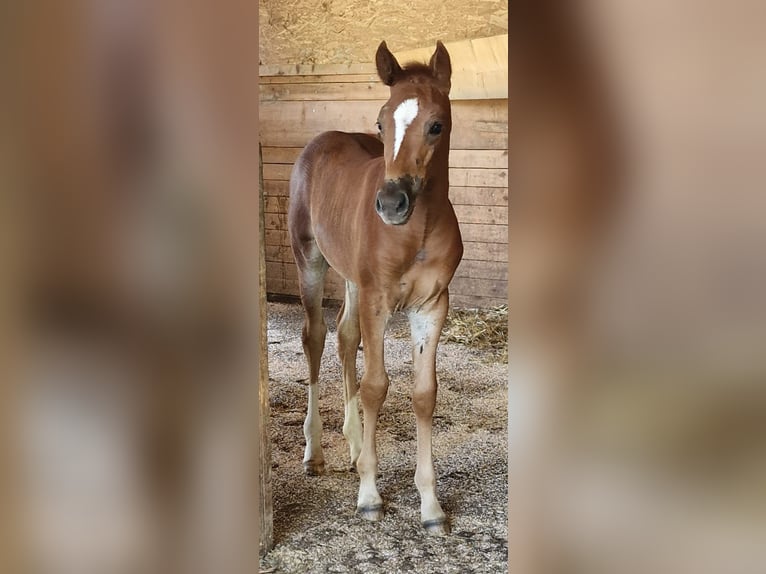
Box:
(260, 44, 508, 307)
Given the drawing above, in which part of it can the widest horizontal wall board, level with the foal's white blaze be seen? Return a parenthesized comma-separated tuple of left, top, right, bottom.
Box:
(259, 100, 508, 151)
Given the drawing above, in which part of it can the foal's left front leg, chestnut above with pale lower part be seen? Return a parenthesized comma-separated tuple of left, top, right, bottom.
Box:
(356, 290, 390, 521)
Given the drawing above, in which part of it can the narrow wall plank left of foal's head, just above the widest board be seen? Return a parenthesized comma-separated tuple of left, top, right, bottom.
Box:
(259, 80, 390, 102)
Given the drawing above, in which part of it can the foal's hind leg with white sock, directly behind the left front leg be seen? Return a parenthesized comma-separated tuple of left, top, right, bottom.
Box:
(338, 281, 362, 468)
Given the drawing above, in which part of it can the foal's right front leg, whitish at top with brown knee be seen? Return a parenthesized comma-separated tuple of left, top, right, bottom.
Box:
(409, 291, 449, 535)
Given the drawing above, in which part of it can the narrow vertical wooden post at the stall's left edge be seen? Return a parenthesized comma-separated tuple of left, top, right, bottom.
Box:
(258, 144, 274, 555)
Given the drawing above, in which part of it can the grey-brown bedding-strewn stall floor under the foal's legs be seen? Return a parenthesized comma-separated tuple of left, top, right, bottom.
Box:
(261, 303, 508, 574)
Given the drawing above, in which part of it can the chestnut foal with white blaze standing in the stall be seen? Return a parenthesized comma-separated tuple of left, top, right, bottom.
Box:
(288, 42, 463, 534)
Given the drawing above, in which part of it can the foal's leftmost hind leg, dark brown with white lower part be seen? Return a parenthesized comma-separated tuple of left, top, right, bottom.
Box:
(293, 239, 328, 475)
